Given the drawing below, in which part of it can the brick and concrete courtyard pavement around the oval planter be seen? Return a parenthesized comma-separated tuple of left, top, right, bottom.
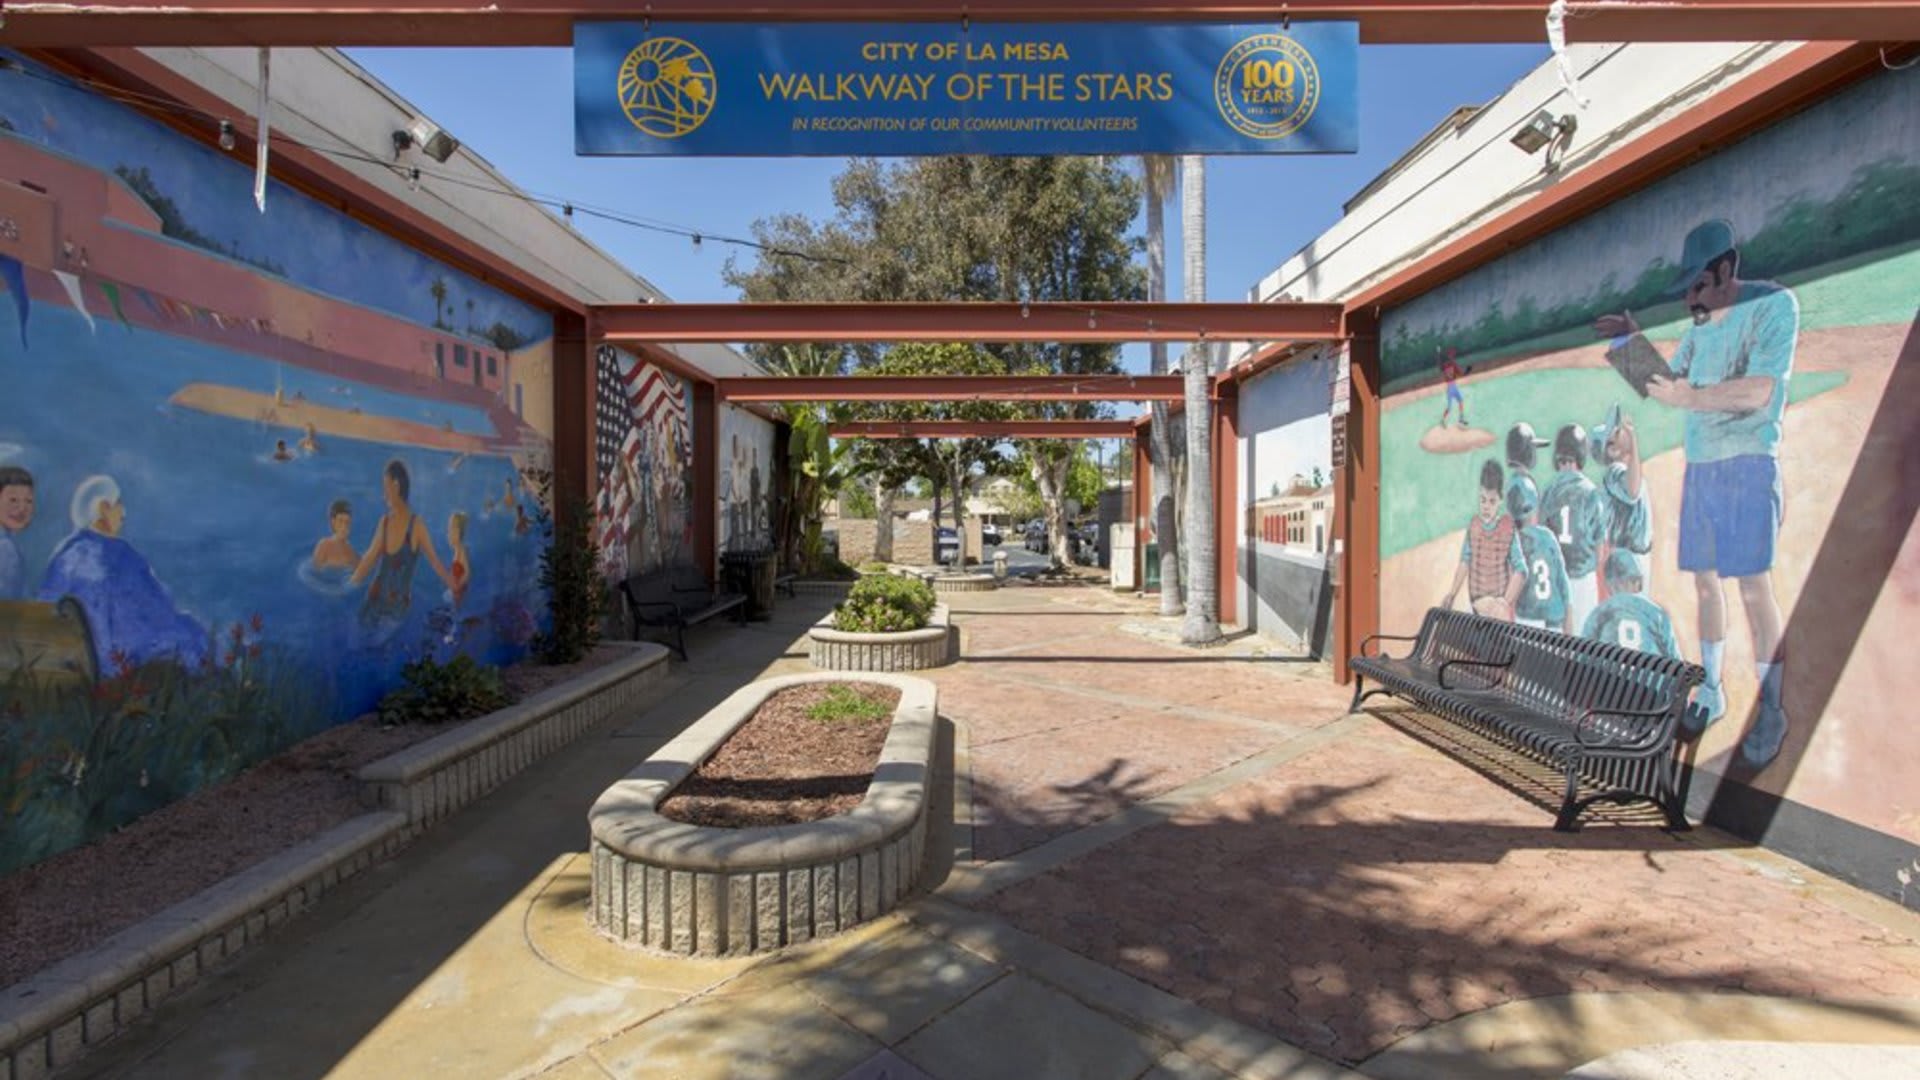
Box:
(81, 584, 1920, 1080)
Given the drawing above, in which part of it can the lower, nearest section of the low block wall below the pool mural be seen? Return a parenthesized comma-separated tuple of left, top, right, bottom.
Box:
(0, 813, 409, 1080)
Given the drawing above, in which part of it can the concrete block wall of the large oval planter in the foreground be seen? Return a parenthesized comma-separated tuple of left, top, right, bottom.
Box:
(588, 675, 937, 955)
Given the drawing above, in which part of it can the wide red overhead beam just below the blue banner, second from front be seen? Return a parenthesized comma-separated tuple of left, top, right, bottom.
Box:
(593, 304, 1344, 344)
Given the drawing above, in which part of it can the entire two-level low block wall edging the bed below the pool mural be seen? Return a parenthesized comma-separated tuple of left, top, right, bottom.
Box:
(0, 642, 666, 1080)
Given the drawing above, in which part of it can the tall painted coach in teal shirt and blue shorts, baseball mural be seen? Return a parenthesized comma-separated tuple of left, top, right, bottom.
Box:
(1594, 221, 1799, 769)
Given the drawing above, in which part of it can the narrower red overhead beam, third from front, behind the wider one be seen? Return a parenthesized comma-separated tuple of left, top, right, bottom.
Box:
(714, 375, 1185, 404)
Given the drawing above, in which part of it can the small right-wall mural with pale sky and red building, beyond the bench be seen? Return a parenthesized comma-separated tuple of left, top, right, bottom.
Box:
(1235, 350, 1334, 655)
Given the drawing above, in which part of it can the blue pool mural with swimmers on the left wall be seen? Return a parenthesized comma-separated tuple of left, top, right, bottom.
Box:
(0, 54, 553, 872)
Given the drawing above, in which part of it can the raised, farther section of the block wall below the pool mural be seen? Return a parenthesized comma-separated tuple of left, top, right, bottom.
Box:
(359, 642, 668, 828)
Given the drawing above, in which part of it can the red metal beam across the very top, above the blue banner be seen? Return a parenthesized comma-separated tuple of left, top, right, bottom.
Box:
(0, 0, 1920, 48)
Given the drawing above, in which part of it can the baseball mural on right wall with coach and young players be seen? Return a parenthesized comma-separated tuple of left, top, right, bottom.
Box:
(1380, 67, 1920, 857)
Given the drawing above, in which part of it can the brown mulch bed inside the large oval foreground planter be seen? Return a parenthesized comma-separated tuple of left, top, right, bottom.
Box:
(660, 682, 900, 828)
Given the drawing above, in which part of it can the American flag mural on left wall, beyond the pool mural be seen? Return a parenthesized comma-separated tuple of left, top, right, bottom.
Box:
(593, 346, 693, 577)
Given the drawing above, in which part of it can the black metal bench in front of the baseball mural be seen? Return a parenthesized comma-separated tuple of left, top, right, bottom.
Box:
(1352, 607, 1707, 832)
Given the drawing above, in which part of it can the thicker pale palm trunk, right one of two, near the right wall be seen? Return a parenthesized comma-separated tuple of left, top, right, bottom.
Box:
(1181, 154, 1219, 646)
